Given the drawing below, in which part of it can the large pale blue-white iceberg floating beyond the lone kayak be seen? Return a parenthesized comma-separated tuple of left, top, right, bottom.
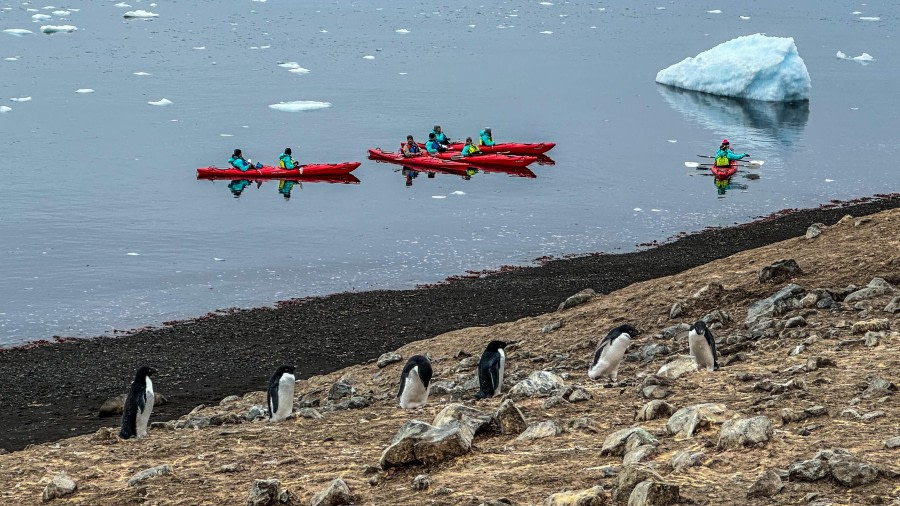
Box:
(656, 33, 812, 102)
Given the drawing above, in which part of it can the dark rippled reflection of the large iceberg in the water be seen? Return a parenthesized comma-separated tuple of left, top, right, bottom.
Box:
(657, 84, 809, 149)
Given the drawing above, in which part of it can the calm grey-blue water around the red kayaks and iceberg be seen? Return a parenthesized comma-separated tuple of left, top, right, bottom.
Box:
(0, 0, 900, 345)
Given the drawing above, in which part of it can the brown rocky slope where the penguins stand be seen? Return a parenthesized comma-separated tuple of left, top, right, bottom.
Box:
(0, 210, 900, 505)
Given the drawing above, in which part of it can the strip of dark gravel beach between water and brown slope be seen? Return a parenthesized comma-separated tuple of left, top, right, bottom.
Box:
(0, 195, 900, 450)
